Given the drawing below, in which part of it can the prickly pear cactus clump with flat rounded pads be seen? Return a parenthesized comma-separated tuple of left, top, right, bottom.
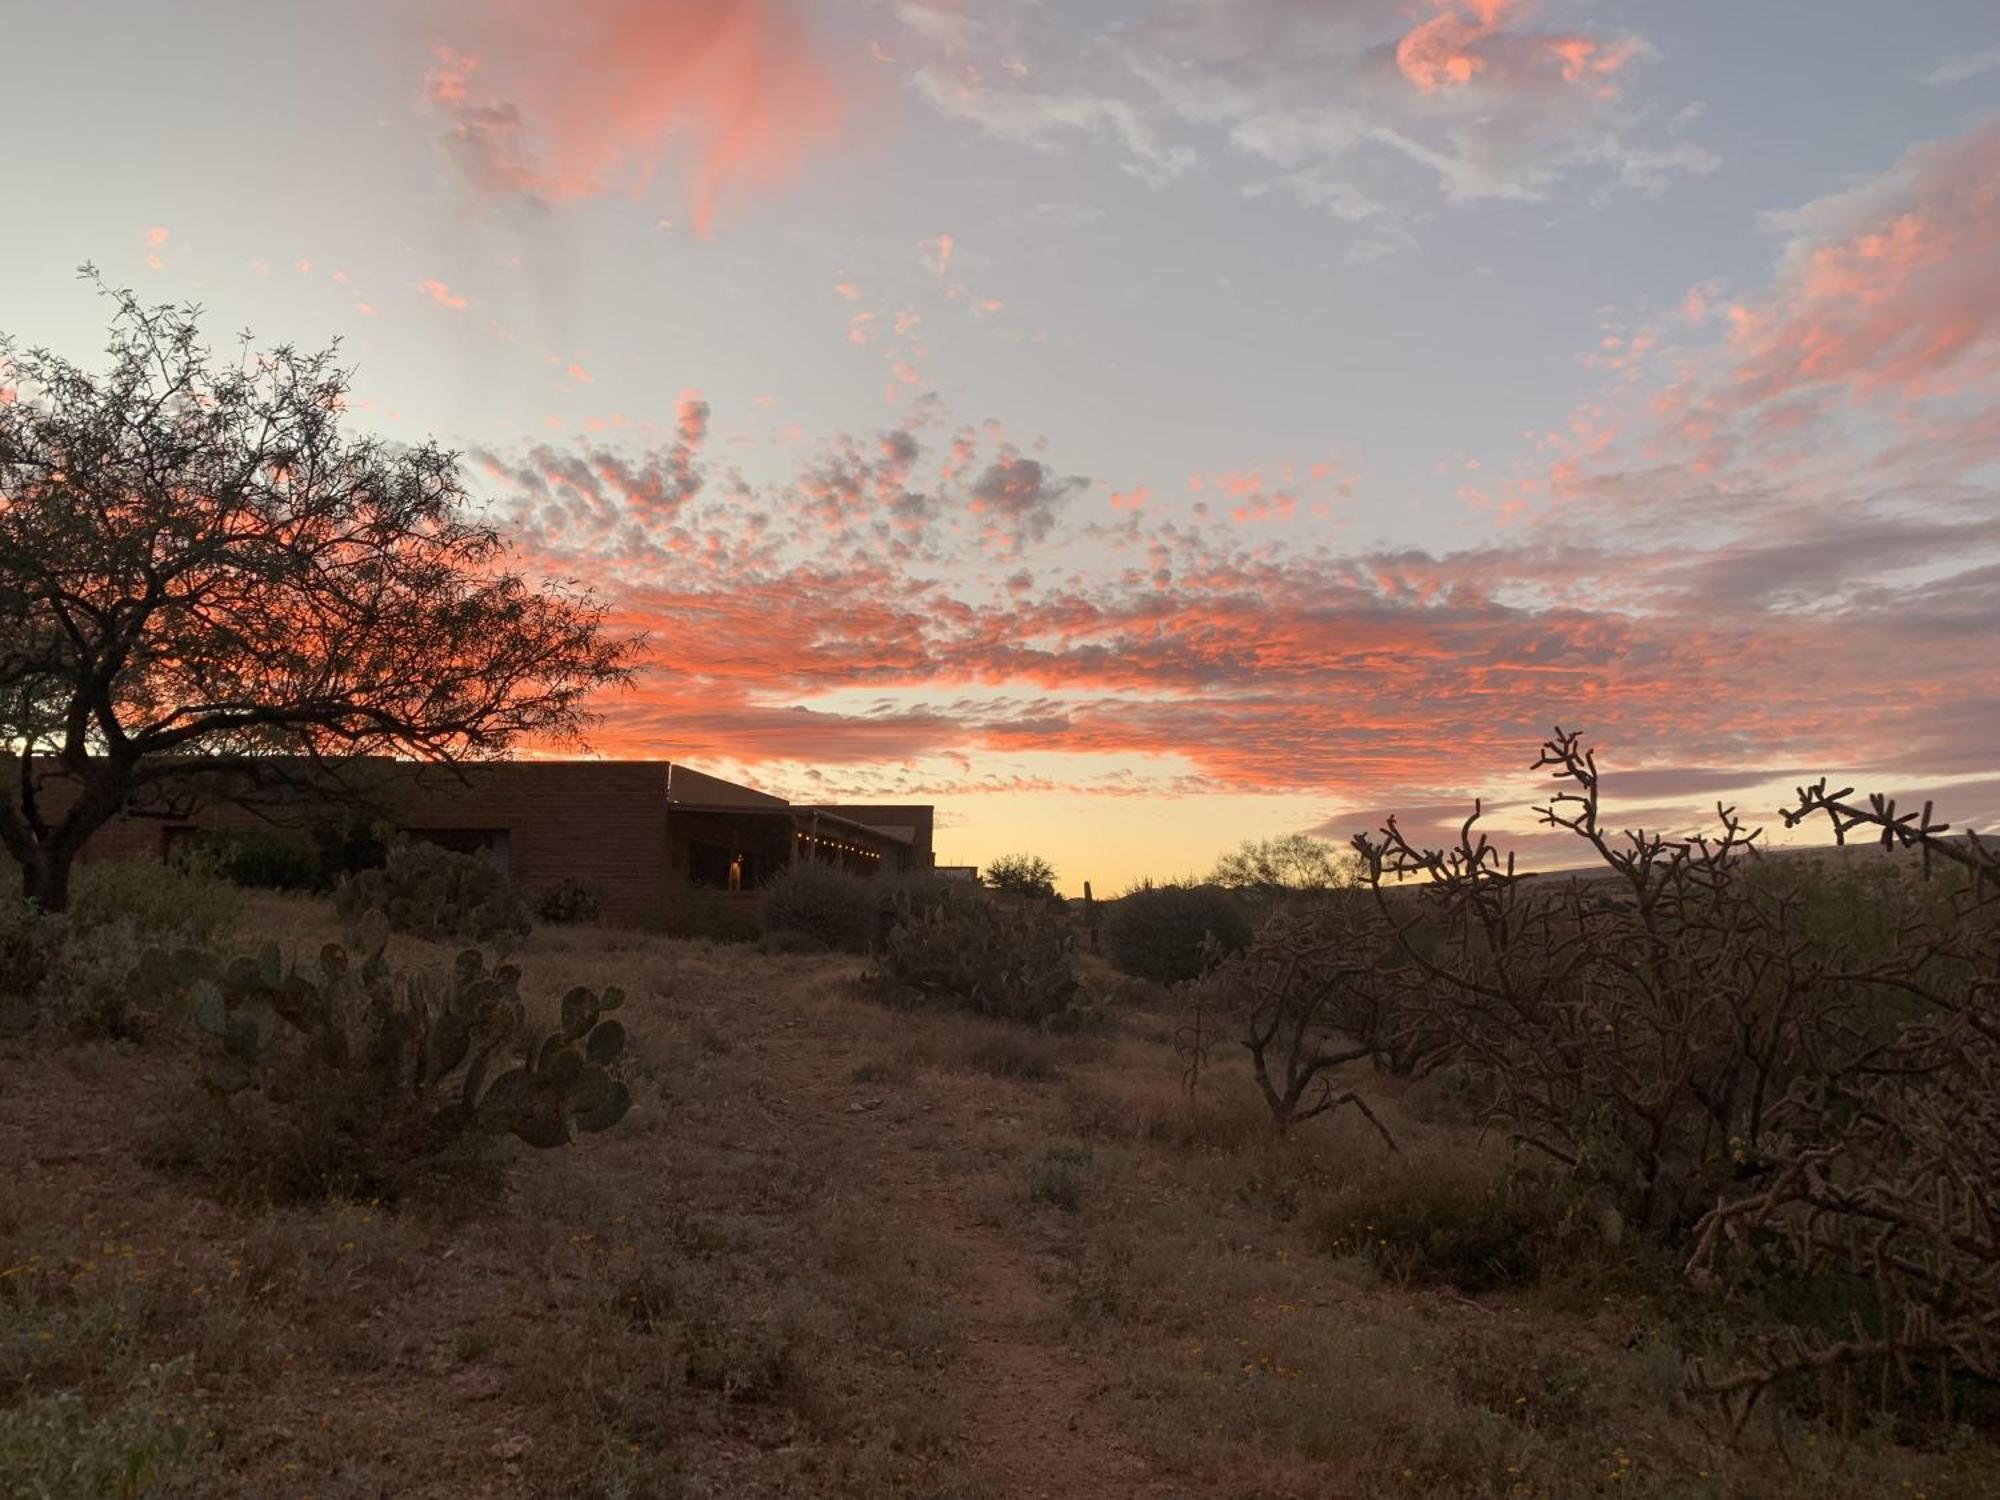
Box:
(160, 944, 630, 1200)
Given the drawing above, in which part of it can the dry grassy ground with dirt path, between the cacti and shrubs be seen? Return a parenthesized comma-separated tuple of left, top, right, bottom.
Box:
(0, 900, 2000, 1500)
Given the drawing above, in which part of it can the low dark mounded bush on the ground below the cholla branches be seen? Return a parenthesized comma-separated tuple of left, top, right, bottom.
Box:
(1304, 1154, 1596, 1292)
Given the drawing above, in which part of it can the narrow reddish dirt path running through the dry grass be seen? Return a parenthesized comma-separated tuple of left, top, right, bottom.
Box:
(766, 980, 1188, 1500)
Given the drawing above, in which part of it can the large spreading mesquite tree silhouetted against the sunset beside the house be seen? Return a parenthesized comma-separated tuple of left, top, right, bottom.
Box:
(0, 266, 638, 910)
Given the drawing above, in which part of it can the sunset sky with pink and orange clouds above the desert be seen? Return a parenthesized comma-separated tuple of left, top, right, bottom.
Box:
(0, 0, 2000, 894)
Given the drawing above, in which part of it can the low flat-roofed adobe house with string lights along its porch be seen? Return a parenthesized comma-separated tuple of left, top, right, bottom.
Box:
(29, 760, 936, 926)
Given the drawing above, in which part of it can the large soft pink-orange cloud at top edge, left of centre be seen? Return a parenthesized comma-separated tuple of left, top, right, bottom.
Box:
(424, 0, 842, 234)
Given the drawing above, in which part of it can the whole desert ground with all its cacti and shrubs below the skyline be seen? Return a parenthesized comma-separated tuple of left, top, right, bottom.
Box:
(0, 734, 2000, 1498)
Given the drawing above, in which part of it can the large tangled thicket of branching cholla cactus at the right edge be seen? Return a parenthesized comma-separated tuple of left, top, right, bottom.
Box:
(1356, 730, 2000, 1400)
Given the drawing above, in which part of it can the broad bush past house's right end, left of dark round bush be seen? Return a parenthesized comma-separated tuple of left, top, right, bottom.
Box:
(870, 892, 1092, 1028)
